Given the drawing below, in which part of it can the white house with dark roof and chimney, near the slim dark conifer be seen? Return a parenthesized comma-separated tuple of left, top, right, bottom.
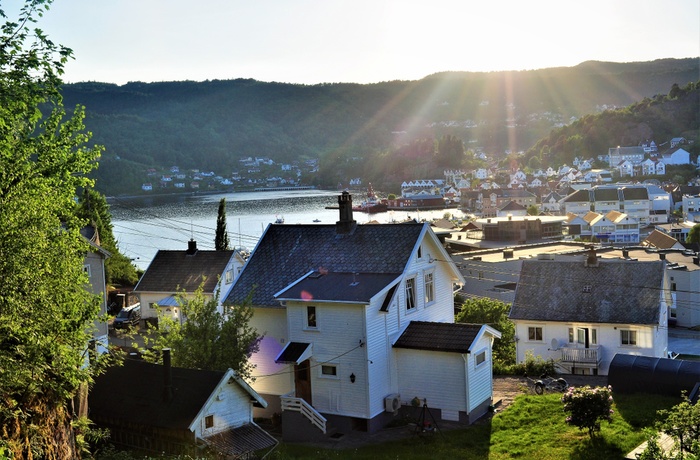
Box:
(134, 240, 245, 319)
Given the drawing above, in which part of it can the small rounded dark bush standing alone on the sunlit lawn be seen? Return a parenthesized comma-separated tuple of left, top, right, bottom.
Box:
(561, 385, 613, 437)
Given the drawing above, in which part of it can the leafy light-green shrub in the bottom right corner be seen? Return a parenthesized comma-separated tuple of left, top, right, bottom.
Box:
(657, 394, 700, 459)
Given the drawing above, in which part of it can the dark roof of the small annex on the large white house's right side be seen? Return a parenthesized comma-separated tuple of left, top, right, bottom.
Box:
(394, 321, 482, 353)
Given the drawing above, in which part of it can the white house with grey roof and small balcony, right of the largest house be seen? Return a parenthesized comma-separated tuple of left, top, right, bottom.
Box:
(509, 249, 673, 375)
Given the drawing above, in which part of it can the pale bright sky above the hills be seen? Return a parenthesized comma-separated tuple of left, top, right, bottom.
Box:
(20, 0, 700, 85)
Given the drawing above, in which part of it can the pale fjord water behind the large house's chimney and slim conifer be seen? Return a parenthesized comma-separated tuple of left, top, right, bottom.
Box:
(108, 190, 462, 270)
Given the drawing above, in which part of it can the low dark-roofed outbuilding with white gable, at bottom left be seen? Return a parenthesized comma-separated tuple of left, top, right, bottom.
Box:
(88, 353, 277, 458)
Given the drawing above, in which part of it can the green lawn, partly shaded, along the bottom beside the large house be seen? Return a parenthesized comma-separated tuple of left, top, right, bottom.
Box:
(271, 394, 680, 460)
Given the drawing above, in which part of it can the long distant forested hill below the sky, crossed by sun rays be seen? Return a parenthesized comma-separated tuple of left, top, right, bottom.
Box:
(63, 58, 700, 193)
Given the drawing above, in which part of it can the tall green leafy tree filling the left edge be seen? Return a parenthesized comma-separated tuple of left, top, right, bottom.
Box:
(0, 0, 101, 459)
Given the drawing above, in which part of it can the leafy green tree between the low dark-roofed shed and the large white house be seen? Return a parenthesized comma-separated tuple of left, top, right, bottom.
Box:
(142, 285, 262, 379)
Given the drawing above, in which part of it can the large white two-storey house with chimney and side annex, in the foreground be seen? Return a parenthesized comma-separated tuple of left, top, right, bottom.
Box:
(227, 192, 500, 440)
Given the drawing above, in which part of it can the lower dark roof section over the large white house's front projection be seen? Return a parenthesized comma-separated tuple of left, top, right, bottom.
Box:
(276, 272, 401, 303)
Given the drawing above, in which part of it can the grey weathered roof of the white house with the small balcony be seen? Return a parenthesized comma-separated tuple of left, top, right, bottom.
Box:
(509, 259, 664, 324)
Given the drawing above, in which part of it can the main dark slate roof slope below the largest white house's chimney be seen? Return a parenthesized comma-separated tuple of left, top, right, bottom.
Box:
(226, 223, 428, 307)
